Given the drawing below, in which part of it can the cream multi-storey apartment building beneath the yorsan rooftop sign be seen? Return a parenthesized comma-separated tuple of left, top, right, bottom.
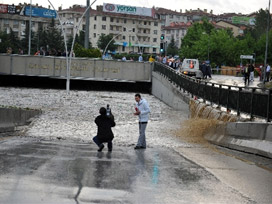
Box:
(58, 4, 161, 54)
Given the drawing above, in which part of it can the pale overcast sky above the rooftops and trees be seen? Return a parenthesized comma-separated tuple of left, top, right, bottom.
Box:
(0, 0, 269, 14)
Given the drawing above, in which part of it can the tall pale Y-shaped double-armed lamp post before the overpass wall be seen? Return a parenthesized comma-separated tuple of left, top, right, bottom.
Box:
(48, 0, 96, 94)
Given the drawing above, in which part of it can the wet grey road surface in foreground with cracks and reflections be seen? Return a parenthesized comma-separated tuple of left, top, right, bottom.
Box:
(0, 137, 255, 204)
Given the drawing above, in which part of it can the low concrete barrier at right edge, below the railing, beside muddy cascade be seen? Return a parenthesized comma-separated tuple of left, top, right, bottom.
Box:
(205, 122, 272, 158)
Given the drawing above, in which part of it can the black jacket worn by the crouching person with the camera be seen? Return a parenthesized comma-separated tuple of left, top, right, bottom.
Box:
(94, 115, 115, 142)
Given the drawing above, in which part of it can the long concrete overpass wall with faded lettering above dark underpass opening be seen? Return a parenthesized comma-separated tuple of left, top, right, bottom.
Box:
(0, 54, 152, 82)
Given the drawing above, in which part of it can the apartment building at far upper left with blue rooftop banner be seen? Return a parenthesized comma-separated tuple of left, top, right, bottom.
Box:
(0, 4, 56, 39)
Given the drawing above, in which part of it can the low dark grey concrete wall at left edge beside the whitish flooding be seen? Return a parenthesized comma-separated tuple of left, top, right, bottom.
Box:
(0, 108, 41, 132)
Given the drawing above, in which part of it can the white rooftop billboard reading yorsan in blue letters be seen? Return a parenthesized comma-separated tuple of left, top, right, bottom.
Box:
(103, 3, 153, 17)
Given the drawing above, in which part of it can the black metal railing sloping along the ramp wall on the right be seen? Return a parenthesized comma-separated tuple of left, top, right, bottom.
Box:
(153, 62, 272, 122)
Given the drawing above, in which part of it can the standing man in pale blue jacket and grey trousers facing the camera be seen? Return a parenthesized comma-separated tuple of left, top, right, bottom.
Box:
(134, 93, 150, 149)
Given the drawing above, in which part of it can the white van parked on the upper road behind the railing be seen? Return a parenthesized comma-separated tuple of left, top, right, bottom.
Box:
(179, 59, 203, 78)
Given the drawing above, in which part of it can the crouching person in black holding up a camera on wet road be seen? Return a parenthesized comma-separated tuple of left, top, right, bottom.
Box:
(93, 107, 115, 152)
